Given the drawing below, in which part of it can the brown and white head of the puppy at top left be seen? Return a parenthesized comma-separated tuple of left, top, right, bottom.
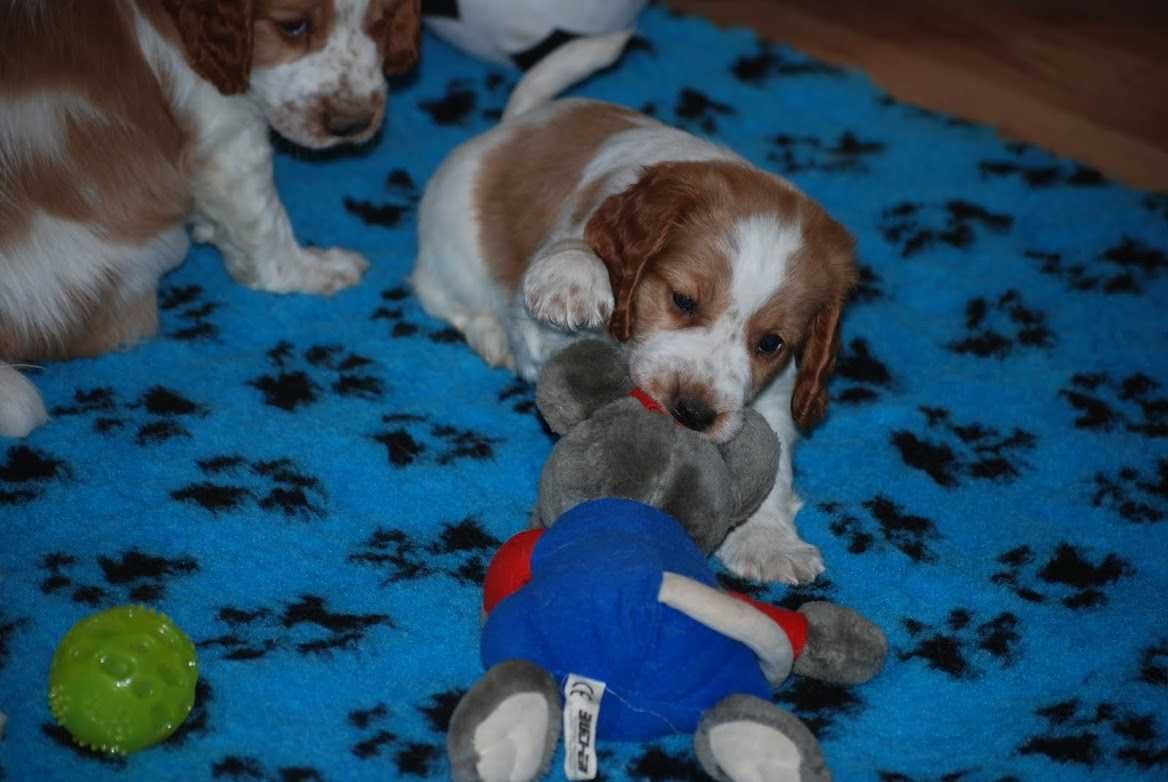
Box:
(164, 0, 422, 149)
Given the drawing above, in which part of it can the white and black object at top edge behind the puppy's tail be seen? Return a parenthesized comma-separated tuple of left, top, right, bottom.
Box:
(422, 0, 648, 70)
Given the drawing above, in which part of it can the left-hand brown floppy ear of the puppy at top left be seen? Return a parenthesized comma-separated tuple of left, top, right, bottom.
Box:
(162, 0, 253, 95)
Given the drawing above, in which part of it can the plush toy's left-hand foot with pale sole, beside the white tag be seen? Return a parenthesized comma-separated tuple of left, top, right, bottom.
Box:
(446, 659, 561, 782)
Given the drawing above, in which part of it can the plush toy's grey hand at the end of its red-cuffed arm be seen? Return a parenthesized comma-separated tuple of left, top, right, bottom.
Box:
(794, 601, 888, 684)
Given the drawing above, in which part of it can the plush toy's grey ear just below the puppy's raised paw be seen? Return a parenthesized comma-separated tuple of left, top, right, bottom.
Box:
(535, 340, 633, 434)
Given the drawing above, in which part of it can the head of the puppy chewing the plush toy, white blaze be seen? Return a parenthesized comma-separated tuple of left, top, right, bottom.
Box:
(585, 162, 856, 441)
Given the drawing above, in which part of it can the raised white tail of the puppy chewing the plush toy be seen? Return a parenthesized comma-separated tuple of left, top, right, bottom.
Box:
(503, 29, 633, 120)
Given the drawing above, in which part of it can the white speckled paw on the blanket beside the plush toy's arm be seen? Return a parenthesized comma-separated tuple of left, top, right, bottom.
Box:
(718, 522, 825, 585)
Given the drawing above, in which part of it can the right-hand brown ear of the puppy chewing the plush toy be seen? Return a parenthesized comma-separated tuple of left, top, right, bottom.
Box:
(791, 209, 856, 431)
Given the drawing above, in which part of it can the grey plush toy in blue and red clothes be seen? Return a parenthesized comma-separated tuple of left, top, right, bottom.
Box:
(447, 341, 888, 782)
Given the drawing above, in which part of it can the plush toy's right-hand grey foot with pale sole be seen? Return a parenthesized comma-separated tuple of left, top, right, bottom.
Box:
(694, 694, 832, 782)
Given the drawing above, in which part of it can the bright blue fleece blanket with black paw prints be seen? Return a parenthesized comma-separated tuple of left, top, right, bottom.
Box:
(0, 9, 1168, 782)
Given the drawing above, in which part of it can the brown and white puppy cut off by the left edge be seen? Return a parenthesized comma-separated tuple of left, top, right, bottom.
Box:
(0, 0, 420, 437)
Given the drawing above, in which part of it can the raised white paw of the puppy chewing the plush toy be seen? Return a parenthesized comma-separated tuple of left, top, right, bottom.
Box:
(523, 243, 613, 331)
